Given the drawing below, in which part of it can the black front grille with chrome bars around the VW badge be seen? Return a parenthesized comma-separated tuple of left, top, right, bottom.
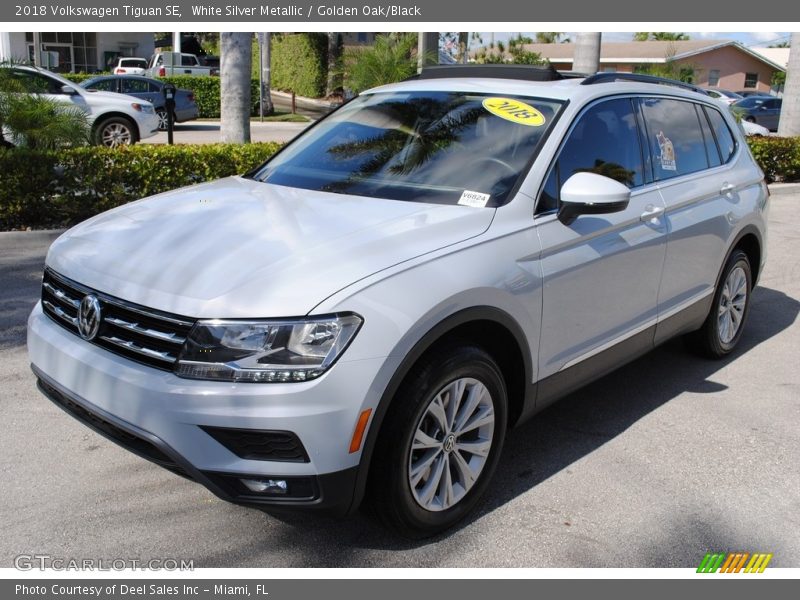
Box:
(42, 269, 194, 371)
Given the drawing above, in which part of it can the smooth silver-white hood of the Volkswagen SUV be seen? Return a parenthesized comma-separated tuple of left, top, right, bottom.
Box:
(47, 177, 495, 318)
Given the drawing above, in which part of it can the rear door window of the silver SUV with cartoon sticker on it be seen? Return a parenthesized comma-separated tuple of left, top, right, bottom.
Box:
(642, 98, 709, 181)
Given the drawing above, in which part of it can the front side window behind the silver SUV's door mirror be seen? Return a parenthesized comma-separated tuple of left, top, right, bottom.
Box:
(536, 98, 644, 213)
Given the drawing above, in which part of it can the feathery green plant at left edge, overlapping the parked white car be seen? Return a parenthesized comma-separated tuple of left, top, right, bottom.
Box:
(0, 62, 90, 150)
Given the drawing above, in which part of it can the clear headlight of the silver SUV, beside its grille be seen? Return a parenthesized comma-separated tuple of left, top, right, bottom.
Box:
(176, 314, 362, 383)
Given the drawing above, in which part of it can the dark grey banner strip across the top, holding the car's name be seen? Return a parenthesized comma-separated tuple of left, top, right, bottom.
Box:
(0, 0, 800, 22)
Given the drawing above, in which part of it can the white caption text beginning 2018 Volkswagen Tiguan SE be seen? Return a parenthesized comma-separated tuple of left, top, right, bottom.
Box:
(14, 4, 423, 19)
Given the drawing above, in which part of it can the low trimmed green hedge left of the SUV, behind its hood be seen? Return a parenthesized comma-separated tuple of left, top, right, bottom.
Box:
(0, 143, 280, 230)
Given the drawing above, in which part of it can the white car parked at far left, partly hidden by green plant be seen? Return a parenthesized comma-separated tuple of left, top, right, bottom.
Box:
(12, 66, 158, 146)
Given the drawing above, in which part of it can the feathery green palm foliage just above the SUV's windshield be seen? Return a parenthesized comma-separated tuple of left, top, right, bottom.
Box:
(344, 33, 417, 93)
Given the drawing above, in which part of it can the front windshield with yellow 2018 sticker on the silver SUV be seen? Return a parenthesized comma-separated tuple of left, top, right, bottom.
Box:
(253, 91, 563, 206)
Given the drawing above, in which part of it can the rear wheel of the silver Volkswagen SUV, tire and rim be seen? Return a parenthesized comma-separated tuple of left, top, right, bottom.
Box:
(690, 249, 753, 358)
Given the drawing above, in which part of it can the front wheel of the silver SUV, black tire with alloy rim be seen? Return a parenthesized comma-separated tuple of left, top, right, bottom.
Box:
(369, 343, 508, 539)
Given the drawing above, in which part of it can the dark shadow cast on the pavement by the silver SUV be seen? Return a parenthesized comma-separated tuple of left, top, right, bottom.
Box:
(238, 287, 800, 556)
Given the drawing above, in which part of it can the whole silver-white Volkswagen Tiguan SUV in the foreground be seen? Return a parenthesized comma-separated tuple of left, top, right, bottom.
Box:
(28, 66, 768, 536)
